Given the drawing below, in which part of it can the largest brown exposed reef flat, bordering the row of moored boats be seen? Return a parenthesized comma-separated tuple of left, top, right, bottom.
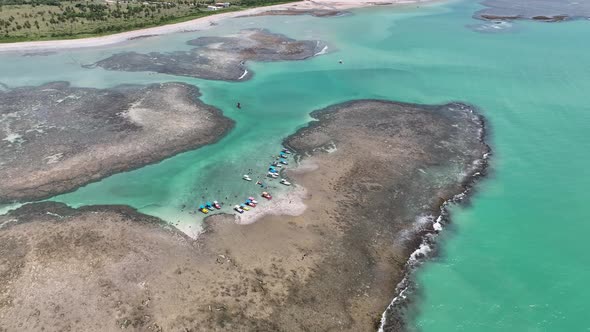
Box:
(0, 100, 488, 331)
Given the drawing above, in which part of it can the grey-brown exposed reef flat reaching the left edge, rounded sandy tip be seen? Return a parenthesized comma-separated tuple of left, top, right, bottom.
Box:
(0, 82, 233, 202)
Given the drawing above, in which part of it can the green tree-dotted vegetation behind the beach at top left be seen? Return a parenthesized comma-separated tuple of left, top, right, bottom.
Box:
(0, 0, 294, 42)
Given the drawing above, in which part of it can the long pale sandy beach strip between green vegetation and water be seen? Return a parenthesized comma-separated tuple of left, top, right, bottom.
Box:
(0, 0, 432, 53)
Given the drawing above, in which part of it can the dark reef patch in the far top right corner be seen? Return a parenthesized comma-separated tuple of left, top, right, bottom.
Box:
(475, 0, 590, 22)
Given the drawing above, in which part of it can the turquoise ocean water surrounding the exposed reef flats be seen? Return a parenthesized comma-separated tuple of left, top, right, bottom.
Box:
(0, 2, 590, 331)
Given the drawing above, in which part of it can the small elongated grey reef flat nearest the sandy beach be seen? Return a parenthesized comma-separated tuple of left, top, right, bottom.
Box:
(87, 29, 326, 81)
